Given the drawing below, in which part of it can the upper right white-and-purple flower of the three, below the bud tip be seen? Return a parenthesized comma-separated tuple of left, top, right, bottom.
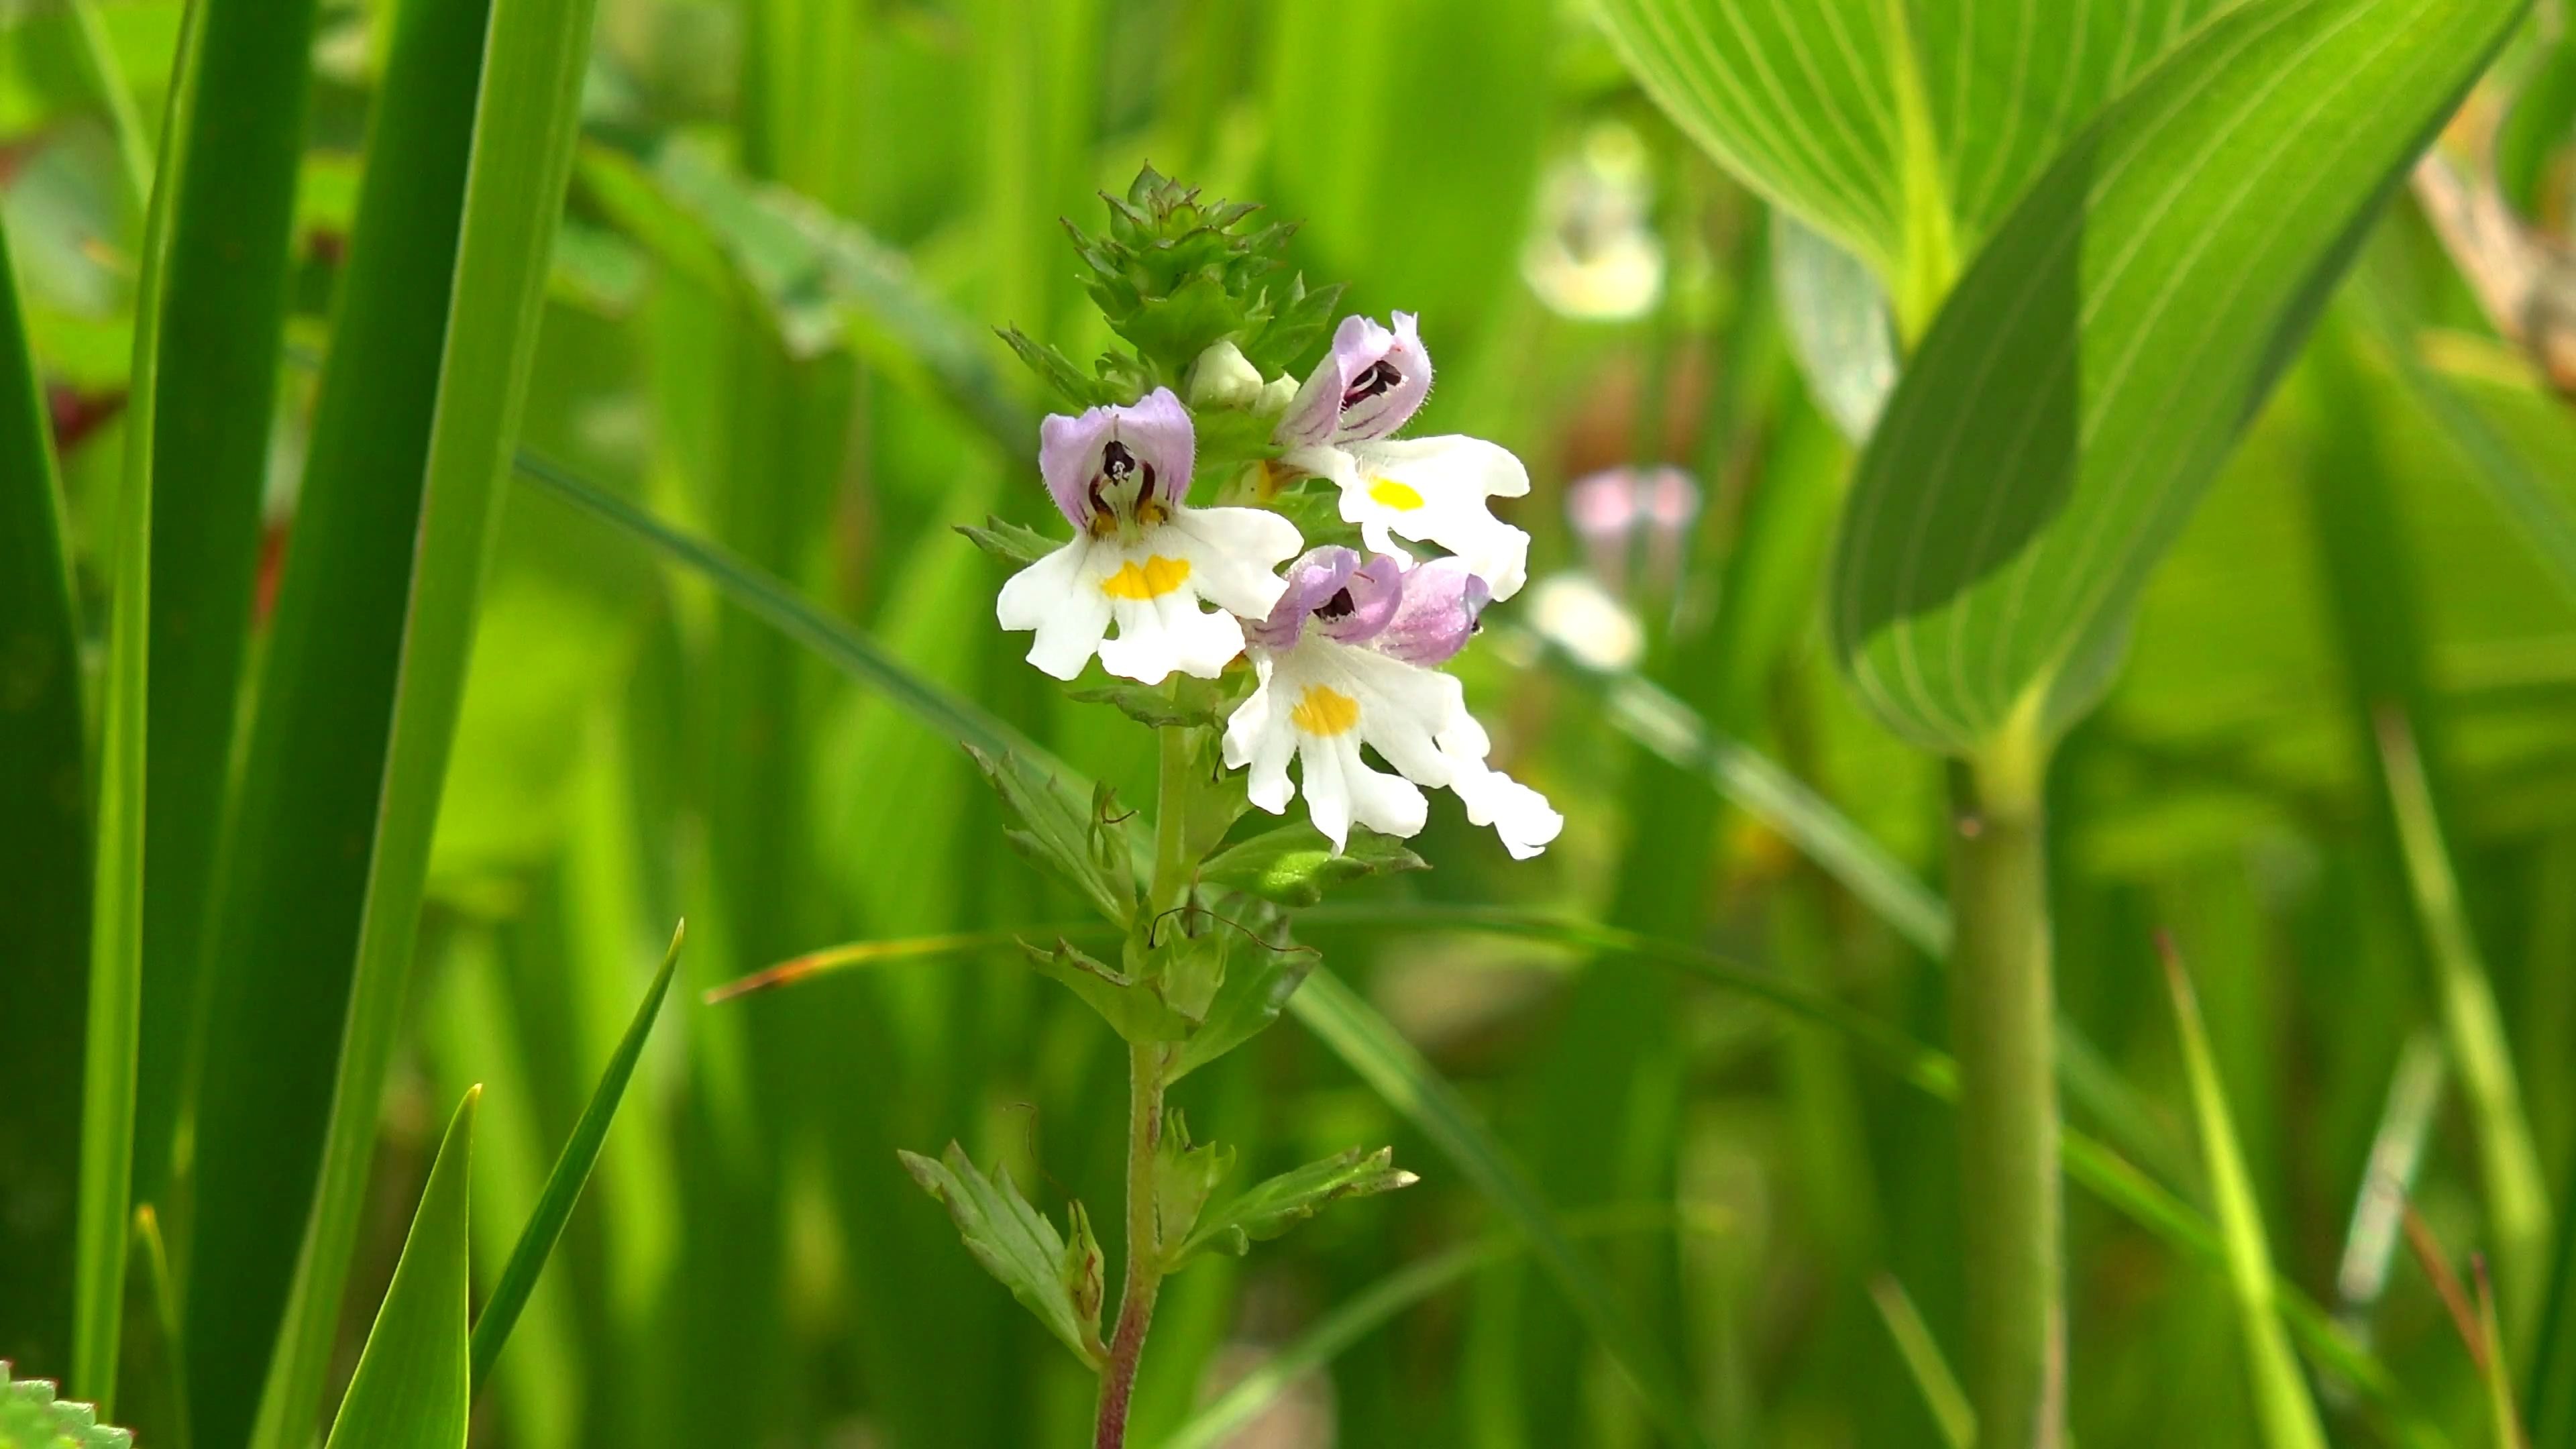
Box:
(1273, 312, 1530, 598)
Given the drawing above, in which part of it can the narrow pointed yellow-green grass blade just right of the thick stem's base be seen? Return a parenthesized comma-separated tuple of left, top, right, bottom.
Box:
(2159, 941, 2326, 1449)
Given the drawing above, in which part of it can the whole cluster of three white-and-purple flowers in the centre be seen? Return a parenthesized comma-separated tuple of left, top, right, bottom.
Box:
(997, 312, 1564, 856)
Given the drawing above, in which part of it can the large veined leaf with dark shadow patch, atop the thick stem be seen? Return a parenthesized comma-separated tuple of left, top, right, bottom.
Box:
(1829, 0, 2522, 753)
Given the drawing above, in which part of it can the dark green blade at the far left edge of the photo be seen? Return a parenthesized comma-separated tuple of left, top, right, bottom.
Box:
(0, 211, 90, 1364)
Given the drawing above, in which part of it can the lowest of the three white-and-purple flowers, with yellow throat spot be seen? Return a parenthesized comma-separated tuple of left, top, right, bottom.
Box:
(1224, 549, 1564, 859)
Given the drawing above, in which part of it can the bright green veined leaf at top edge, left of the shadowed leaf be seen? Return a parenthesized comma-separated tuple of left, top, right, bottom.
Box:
(1600, 0, 2233, 325)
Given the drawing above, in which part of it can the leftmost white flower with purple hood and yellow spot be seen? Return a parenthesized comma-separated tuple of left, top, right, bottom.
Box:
(997, 387, 1298, 684)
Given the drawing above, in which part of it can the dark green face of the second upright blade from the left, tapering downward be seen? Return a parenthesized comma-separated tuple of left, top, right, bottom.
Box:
(134, 0, 329, 1201)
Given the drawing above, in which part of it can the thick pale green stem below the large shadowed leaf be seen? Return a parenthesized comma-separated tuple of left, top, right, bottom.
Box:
(1950, 735, 2066, 1449)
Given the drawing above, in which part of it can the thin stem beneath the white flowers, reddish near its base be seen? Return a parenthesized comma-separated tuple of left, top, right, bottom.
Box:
(1092, 727, 1198, 1449)
